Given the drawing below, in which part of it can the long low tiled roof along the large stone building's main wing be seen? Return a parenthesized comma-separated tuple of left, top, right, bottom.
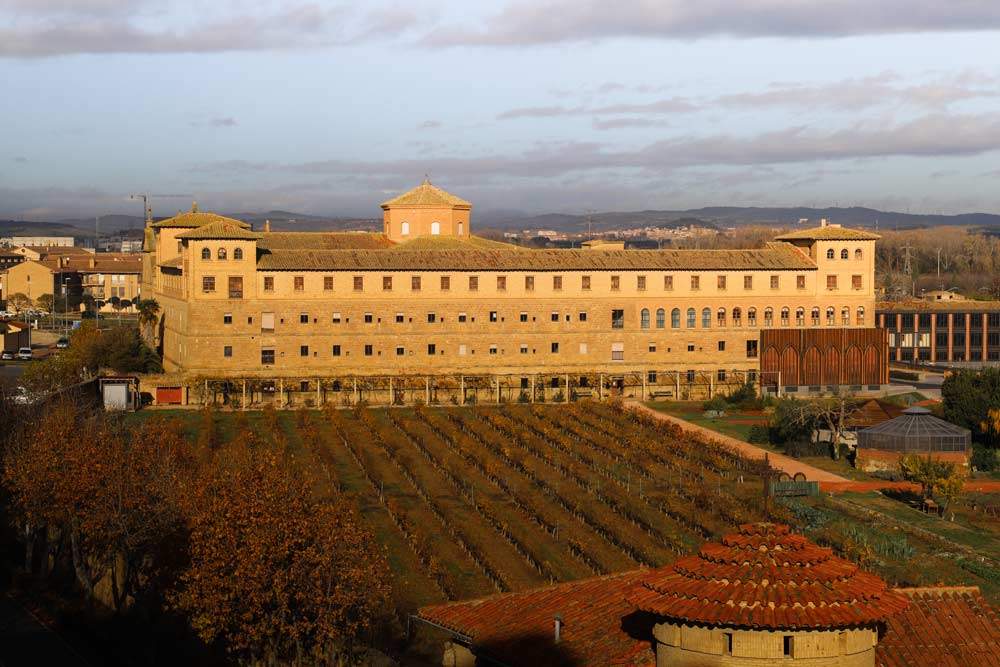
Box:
(257, 240, 816, 272)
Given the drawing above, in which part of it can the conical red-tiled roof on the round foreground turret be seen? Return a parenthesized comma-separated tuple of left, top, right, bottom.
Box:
(629, 523, 908, 630)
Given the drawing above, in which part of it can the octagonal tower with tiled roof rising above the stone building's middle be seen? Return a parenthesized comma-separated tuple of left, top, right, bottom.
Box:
(382, 178, 472, 243)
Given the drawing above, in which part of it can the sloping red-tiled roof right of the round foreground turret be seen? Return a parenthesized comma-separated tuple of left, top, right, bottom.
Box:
(875, 587, 1000, 667)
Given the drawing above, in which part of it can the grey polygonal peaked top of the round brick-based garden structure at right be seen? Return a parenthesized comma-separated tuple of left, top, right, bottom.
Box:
(858, 407, 972, 454)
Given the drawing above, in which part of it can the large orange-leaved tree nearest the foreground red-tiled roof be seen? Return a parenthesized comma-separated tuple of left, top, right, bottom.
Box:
(171, 442, 389, 664)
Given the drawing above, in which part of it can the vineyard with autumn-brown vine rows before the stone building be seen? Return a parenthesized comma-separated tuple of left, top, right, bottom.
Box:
(164, 402, 767, 615)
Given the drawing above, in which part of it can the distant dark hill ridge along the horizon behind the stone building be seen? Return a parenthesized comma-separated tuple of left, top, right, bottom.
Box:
(0, 206, 1000, 238)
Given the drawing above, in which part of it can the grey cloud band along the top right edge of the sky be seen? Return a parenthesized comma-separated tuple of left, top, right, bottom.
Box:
(421, 0, 1000, 47)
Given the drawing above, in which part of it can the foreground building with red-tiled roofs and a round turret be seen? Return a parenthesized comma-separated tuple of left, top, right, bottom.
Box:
(416, 524, 1000, 667)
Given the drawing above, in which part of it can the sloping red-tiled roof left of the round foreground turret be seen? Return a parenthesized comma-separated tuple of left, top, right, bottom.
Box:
(418, 570, 656, 667)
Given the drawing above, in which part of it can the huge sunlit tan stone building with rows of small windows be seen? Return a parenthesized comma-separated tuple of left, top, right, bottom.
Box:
(143, 181, 884, 402)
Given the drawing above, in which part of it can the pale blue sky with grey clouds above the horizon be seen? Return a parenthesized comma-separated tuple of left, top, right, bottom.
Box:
(0, 0, 1000, 220)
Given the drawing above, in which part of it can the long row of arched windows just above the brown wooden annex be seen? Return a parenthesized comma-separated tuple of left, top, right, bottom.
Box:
(639, 306, 865, 329)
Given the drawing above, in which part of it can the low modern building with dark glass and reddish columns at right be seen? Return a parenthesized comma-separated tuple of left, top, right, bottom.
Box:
(876, 298, 1000, 367)
